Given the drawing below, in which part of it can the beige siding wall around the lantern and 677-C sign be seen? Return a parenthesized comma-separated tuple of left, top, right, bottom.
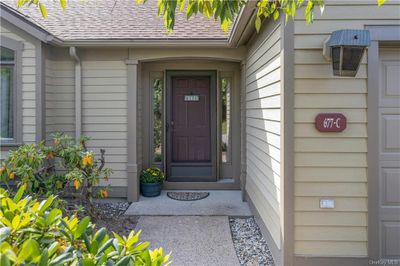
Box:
(294, 1, 400, 257)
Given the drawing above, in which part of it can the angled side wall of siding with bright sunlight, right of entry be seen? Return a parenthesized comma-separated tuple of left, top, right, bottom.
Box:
(246, 18, 281, 248)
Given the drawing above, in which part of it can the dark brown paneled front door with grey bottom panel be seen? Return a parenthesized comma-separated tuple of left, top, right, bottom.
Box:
(167, 72, 214, 181)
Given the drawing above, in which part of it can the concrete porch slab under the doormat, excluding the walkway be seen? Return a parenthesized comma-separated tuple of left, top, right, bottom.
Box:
(125, 190, 252, 216)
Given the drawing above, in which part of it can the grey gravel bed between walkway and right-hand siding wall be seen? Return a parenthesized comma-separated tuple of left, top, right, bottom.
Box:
(229, 217, 274, 266)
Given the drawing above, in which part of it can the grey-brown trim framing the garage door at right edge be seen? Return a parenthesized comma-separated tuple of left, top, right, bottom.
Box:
(366, 25, 400, 259)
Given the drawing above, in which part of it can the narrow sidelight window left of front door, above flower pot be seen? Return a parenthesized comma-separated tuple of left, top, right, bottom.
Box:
(152, 78, 163, 163)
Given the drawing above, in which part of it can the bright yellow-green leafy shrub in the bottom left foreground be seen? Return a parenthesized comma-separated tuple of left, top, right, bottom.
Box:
(0, 186, 169, 266)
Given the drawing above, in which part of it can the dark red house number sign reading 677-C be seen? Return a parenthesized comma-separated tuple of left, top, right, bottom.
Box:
(315, 113, 346, 132)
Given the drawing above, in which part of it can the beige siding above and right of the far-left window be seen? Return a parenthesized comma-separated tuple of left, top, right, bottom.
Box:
(0, 24, 36, 143)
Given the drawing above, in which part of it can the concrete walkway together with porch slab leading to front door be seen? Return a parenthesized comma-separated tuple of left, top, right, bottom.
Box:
(125, 190, 252, 266)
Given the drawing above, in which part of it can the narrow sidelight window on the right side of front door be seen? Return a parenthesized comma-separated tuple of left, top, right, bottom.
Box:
(221, 78, 232, 163)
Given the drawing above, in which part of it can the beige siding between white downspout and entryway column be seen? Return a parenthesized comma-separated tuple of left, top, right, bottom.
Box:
(82, 58, 128, 187)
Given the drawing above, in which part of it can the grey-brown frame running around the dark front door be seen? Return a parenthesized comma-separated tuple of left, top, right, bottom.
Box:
(164, 70, 218, 182)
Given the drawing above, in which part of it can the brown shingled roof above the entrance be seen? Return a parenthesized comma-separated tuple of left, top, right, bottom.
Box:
(1, 0, 230, 41)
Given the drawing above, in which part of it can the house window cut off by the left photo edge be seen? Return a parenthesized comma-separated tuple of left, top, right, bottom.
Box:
(0, 47, 15, 142)
